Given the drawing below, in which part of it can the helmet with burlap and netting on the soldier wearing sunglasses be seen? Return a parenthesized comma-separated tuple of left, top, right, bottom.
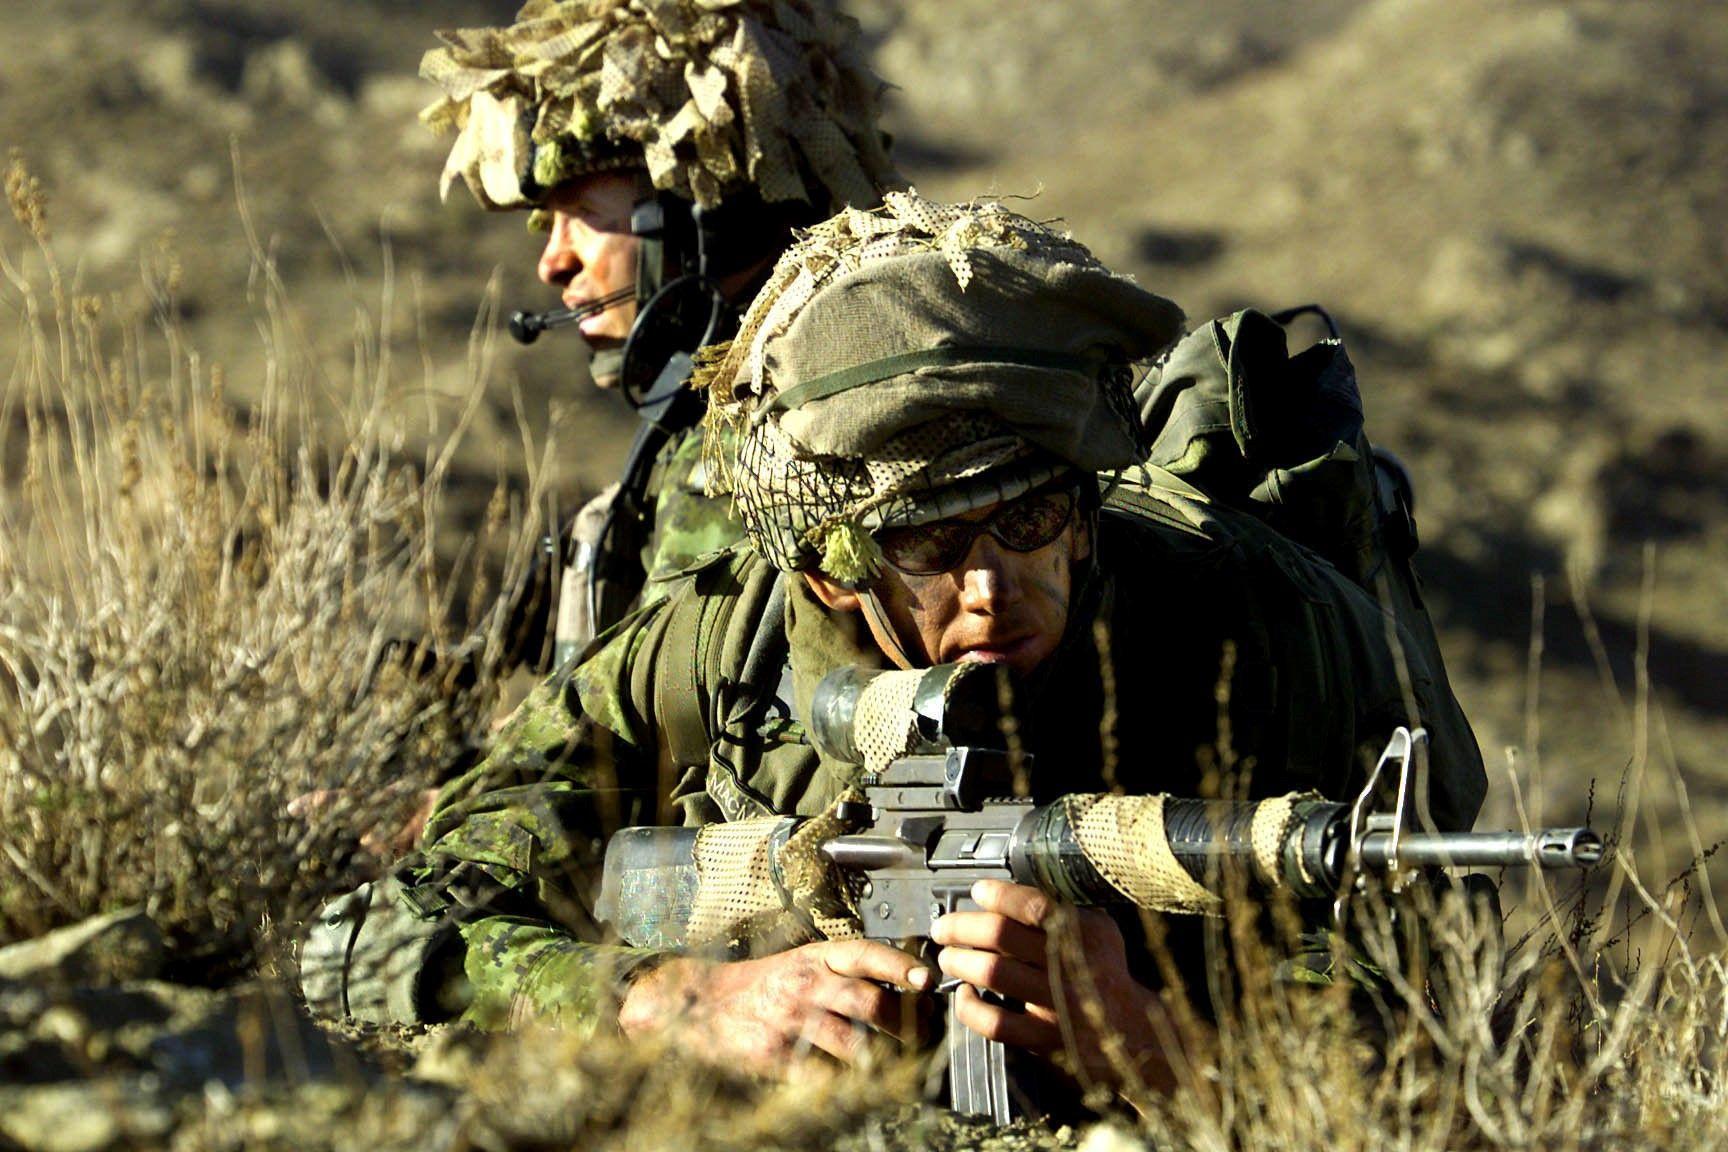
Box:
(695, 192, 1182, 585)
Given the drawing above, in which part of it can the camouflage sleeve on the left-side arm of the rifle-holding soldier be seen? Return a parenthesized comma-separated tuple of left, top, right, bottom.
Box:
(401, 551, 781, 1028)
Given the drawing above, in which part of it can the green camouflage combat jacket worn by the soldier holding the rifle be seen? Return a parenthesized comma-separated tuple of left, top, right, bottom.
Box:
(306, 468, 1486, 1028)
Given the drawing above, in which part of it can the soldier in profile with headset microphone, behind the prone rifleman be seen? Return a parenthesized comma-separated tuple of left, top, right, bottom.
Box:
(422, 0, 899, 663)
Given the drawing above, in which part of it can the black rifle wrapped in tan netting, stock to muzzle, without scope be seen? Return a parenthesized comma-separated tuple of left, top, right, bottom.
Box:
(607, 794, 1602, 946)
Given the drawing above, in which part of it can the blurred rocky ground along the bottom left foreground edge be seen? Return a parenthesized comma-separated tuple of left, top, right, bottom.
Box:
(0, 910, 1105, 1152)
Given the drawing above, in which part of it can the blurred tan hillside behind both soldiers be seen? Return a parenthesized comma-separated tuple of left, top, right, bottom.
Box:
(0, 0, 1728, 865)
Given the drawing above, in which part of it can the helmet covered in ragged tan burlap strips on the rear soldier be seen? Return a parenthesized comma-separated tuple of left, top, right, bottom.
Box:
(420, 0, 899, 212)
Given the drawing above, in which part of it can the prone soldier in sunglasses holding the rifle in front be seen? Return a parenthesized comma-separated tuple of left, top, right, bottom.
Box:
(308, 193, 1484, 1105)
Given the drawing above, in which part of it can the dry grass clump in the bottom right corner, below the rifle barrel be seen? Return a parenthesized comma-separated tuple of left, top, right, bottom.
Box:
(1105, 873, 1728, 1150)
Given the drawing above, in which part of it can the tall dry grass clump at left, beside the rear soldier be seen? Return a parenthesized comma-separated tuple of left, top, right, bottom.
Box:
(0, 148, 536, 955)
